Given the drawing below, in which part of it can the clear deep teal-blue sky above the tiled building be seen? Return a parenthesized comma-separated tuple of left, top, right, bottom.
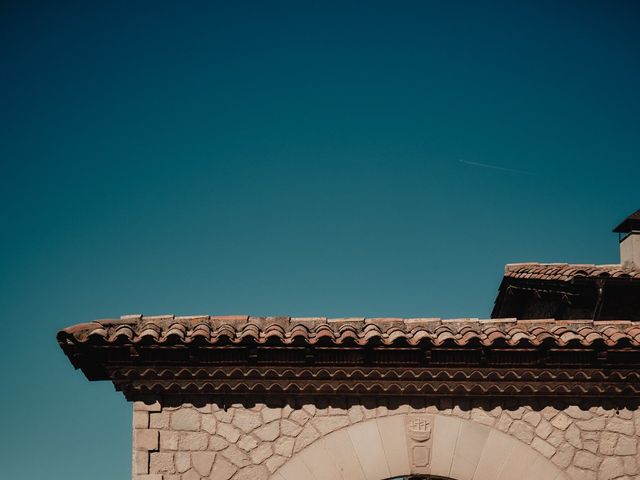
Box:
(0, 0, 640, 480)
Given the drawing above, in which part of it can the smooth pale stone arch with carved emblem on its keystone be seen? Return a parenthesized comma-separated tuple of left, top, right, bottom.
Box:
(271, 414, 568, 480)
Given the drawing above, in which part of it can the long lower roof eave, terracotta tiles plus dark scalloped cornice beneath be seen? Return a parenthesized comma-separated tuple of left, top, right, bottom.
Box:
(58, 316, 640, 399)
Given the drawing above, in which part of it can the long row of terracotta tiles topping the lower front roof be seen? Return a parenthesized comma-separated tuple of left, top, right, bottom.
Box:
(58, 315, 640, 347)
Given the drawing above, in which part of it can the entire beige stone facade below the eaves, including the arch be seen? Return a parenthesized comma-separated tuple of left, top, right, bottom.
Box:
(133, 399, 640, 480)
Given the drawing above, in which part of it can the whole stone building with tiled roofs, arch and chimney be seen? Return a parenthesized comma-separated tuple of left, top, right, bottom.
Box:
(58, 212, 640, 480)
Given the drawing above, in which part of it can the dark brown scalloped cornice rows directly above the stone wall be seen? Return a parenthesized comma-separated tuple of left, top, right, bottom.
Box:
(110, 367, 640, 400)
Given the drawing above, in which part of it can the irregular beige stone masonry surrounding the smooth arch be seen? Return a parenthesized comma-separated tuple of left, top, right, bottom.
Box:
(133, 399, 640, 480)
